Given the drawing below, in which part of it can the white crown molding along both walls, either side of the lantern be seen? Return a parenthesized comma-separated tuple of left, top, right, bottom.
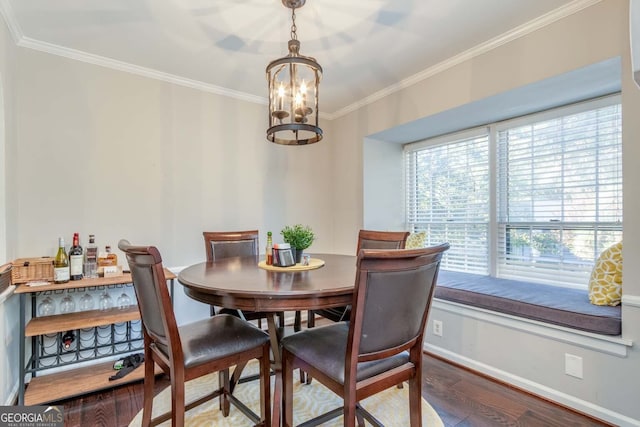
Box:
(0, 0, 602, 120)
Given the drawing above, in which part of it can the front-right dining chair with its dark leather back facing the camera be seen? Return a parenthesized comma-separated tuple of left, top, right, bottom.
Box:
(281, 243, 449, 427)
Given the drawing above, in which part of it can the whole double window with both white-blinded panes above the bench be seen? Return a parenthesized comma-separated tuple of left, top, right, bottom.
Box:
(405, 96, 622, 287)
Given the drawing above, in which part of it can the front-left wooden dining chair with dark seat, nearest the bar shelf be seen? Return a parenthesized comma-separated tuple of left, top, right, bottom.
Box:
(118, 239, 271, 427)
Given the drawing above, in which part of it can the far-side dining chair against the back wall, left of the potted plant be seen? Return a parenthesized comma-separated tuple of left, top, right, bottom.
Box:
(202, 230, 284, 328)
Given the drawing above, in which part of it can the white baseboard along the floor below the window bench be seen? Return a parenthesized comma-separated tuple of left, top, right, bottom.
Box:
(424, 343, 640, 427)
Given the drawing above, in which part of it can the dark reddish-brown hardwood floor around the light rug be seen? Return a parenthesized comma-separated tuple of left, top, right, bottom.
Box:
(51, 355, 608, 427)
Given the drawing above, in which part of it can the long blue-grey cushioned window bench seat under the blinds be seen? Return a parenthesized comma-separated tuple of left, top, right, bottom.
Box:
(434, 270, 622, 335)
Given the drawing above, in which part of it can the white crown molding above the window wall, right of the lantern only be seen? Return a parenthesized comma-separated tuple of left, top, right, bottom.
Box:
(328, 0, 602, 120)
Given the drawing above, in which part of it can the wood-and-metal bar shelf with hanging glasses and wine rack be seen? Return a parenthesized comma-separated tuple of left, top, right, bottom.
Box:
(14, 269, 176, 405)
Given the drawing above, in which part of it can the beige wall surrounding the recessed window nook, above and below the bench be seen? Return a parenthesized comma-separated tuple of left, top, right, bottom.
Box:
(332, 0, 640, 426)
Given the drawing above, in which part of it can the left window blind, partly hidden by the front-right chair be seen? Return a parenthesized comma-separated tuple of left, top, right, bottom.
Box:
(405, 129, 489, 274)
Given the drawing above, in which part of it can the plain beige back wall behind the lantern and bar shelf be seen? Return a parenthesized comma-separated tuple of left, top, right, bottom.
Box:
(10, 49, 334, 266)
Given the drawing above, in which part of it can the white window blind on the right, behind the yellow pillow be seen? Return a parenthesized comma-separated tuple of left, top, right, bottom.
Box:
(497, 100, 622, 287)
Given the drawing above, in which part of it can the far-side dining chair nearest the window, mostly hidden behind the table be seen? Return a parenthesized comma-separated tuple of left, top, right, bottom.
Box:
(307, 230, 409, 328)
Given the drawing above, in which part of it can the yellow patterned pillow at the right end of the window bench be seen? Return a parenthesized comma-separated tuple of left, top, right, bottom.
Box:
(589, 242, 622, 305)
